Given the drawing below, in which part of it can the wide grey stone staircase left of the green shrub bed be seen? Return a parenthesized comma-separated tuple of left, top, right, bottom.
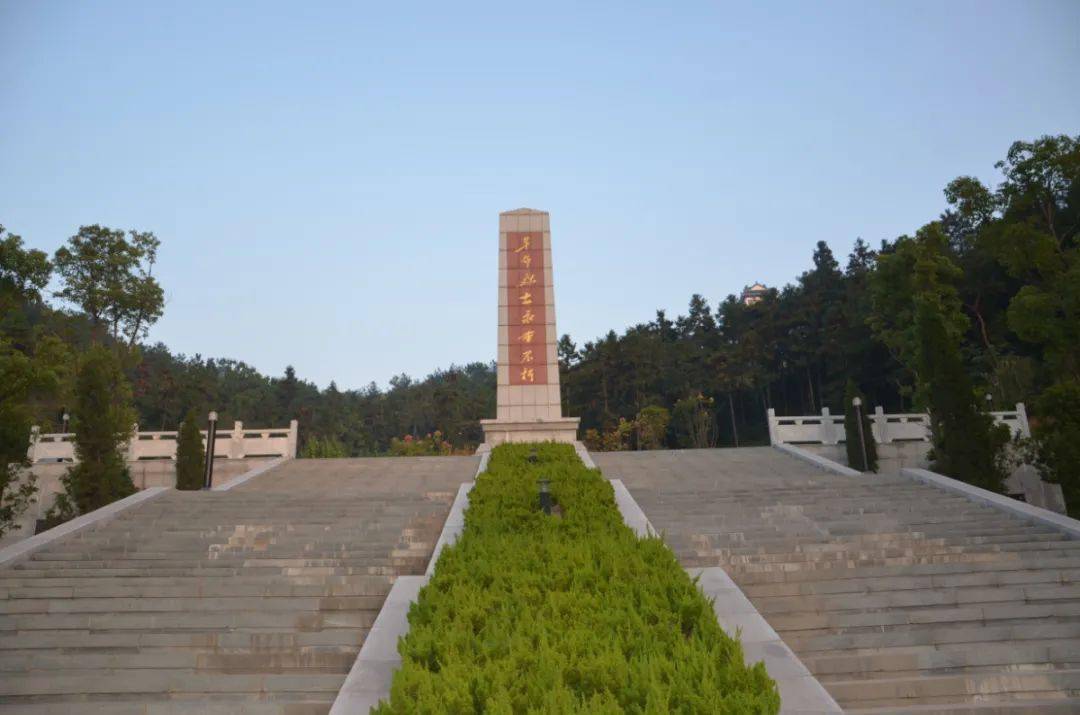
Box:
(0, 457, 478, 715)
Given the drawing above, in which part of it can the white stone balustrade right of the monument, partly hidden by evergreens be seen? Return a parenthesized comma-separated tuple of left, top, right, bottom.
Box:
(769, 402, 1031, 444)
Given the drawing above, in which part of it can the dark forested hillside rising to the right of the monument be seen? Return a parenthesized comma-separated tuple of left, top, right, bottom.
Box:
(559, 136, 1080, 463)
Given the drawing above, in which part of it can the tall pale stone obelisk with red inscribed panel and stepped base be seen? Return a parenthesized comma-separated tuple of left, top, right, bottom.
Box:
(480, 208, 578, 446)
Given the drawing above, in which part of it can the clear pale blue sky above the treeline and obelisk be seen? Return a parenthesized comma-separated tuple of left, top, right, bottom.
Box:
(0, 0, 1080, 388)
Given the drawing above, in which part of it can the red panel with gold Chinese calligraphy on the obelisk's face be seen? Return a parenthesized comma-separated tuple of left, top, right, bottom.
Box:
(507, 231, 548, 385)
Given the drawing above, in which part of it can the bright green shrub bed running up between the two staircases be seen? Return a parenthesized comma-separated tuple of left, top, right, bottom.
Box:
(375, 444, 780, 714)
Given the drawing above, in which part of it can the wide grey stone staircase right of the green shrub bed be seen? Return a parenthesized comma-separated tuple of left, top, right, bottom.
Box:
(593, 447, 1080, 715)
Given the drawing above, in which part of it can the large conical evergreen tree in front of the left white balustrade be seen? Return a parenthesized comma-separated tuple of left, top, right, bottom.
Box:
(57, 345, 135, 514)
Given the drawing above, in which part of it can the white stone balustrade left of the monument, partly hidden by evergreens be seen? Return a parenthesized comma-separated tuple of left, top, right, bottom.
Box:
(26, 419, 297, 464)
